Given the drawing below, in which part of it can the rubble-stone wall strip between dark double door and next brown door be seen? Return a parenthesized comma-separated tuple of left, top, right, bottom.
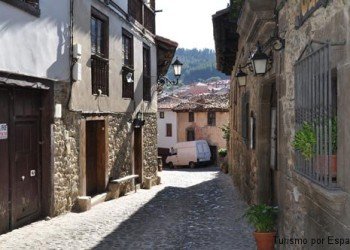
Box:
(53, 83, 80, 215)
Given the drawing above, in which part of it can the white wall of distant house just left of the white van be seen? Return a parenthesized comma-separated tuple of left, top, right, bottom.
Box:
(157, 111, 177, 148)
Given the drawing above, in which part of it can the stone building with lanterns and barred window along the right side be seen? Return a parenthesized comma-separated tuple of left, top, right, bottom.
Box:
(213, 0, 350, 246)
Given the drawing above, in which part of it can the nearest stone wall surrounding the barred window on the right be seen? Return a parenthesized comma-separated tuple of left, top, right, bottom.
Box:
(278, 0, 350, 246)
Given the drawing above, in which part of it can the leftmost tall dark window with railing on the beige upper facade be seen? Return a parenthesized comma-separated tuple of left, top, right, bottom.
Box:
(90, 7, 109, 96)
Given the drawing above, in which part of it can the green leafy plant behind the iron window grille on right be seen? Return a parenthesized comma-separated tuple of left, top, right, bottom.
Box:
(293, 122, 317, 160)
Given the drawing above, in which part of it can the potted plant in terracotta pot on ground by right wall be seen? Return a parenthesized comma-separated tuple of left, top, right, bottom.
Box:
(244, 204, 278, 250)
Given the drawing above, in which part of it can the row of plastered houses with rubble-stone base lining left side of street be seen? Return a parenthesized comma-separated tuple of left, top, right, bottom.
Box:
(0, 0, 177, 233)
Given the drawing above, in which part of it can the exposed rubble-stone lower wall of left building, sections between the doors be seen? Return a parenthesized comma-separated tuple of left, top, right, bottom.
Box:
(53, 81, 158, 215)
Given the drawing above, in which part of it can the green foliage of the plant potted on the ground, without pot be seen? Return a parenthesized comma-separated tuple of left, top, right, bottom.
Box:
(244, 204, 278, 233)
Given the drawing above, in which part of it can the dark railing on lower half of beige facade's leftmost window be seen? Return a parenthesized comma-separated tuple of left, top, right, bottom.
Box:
(91, 55, 109, 95)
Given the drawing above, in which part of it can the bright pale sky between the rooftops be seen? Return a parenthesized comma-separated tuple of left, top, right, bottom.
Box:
(156, 0, 229, 49)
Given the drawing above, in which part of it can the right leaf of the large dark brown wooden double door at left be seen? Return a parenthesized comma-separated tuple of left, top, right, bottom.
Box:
(11, 90, 41, 227)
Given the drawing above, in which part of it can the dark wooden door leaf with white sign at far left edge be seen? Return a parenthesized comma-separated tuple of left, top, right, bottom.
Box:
(0, 89, 10, 234)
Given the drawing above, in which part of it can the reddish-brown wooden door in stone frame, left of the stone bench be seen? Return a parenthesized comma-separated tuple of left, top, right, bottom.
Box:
(86, 121, 106, 196)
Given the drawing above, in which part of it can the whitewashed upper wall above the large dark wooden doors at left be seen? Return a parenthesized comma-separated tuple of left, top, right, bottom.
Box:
(0, 0, 70, 80)
